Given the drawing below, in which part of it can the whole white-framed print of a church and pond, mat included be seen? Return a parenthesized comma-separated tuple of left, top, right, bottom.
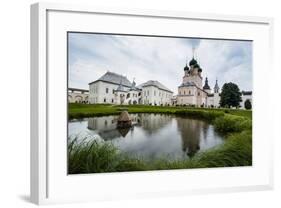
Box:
(31, 3, 273, 204)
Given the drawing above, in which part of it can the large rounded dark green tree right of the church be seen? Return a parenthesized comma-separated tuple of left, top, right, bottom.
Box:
(220, 82, 242, 107)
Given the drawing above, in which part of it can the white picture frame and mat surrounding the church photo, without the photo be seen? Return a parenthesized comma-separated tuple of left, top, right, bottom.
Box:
(31, 3, 273, 204)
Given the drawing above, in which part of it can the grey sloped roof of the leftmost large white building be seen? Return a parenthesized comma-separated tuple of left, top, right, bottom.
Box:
(89, 71, 132, 87)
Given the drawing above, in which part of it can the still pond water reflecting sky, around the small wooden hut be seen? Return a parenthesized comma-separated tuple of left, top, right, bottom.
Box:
(68, 113, 224, 160)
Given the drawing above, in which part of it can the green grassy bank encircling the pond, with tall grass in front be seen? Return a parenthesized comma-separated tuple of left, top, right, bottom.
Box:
(68, 104, 252, 174)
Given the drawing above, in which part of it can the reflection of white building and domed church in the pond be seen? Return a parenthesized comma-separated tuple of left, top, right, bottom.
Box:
(88, 114, 209, 157)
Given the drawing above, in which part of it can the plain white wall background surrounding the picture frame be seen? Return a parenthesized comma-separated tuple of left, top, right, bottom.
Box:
(0, 0, 281, 208)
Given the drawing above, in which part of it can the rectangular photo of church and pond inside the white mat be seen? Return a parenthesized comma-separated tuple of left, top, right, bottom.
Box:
(65, 31, 254, 174)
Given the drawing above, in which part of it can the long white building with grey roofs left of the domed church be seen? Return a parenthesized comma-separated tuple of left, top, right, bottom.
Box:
(89, 72, 173, 105)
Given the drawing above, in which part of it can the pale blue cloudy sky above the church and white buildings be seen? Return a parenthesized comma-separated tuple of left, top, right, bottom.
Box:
(68, 33, 252, 94)
